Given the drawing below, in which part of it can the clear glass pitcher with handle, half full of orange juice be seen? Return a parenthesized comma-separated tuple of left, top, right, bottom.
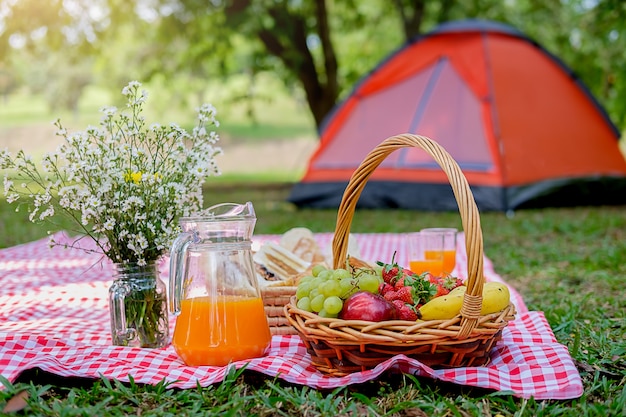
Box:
(169, 202, 272, 366)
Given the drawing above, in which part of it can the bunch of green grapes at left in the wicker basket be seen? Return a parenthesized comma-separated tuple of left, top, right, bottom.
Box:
(296, 264, 383, 318)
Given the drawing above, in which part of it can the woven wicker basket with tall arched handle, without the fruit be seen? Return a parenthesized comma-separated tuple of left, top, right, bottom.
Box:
(284, 134, 515, 376)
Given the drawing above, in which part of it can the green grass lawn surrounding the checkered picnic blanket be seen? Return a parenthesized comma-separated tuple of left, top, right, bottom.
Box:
(0, 181, 626, 417)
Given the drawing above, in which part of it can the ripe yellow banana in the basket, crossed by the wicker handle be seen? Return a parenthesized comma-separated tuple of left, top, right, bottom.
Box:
(418, 281, 511, 321)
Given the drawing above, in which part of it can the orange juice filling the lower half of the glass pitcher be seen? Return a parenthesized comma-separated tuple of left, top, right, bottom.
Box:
(172, 296, 272, 366)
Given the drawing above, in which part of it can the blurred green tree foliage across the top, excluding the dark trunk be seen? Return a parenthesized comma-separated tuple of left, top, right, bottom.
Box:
(0, 0, 626, 130)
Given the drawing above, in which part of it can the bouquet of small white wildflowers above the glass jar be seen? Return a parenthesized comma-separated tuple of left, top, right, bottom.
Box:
(0, 81, 221, 265)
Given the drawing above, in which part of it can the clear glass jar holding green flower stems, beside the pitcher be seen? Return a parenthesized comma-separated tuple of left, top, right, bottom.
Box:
(109, 262, 169, 348)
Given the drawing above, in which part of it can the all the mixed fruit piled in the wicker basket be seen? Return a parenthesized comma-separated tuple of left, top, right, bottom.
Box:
(296, 261, 510, 322)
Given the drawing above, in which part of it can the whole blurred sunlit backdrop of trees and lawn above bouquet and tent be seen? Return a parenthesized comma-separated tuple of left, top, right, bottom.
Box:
(0, 0, 626, 175)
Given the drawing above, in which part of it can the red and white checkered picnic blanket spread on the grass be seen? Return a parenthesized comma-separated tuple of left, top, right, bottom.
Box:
(0, 233, 583, 399)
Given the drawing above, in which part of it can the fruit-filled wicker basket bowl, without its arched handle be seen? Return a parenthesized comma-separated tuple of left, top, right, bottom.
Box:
(284, 258, 515, 376)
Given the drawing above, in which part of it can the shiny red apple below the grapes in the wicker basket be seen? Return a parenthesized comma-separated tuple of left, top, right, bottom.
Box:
(339, 291, 398, 321)
